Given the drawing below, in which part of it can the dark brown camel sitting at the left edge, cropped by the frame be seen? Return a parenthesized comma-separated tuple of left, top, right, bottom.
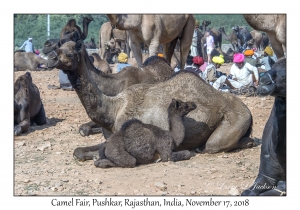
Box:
(14, 72, 47, 136)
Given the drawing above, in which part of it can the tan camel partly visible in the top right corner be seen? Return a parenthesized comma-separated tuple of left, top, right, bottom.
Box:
(243, 14, 286, 59)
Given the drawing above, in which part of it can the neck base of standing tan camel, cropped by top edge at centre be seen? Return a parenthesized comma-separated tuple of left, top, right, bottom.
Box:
(107, 14, 142, 30)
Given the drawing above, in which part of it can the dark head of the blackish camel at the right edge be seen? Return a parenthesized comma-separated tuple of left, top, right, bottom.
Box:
(258, 58, 286, 97)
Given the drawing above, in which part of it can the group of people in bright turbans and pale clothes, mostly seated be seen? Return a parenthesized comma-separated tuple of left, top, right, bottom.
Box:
(184, 41, 277, 91)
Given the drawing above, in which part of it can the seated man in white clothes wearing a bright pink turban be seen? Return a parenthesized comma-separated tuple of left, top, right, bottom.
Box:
(213, 53, 259, 90)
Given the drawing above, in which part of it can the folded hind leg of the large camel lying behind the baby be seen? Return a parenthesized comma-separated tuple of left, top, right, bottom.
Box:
(203, 114, 251, 153)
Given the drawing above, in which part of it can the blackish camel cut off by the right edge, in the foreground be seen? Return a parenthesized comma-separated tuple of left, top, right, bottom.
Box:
(242, 58, 286, 196)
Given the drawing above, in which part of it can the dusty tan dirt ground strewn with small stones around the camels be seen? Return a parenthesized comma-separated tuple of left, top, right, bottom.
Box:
(14, 61, 274, 196)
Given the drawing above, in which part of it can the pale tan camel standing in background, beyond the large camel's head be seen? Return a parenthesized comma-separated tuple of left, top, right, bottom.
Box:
(99, 22, 129, 59)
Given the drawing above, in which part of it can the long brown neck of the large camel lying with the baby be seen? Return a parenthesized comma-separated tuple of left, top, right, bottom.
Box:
(68, 49, 118, 130)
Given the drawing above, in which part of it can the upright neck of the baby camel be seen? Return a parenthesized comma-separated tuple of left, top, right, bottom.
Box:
(168, 111, 185, 147)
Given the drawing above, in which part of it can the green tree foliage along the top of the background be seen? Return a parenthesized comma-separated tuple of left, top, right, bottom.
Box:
(14, 14, 252, 49)
